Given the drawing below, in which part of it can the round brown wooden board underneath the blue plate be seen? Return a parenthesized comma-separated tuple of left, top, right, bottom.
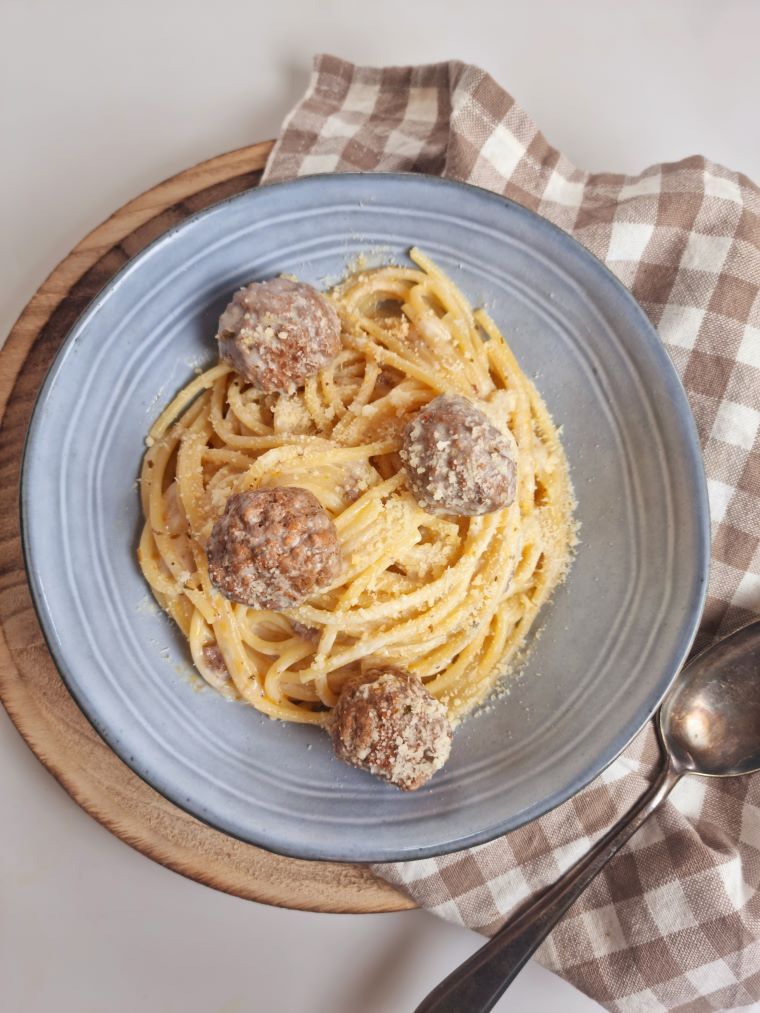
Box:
(0, 141, 413, 913)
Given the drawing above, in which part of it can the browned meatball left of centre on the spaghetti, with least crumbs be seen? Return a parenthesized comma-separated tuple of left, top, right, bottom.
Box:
(206, 486, 340, 609)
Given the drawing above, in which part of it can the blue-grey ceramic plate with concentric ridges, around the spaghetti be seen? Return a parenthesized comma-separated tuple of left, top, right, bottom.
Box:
(22, 174, 708, 861)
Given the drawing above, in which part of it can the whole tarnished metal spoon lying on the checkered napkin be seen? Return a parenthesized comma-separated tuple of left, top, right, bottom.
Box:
(414, 621, 760, 1013)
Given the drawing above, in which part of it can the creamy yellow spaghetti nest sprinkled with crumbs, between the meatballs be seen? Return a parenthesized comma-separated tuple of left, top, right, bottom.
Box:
(139, 249, 575, 724)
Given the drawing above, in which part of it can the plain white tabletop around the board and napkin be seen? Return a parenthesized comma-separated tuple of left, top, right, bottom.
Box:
(0, 0, 760, 1013)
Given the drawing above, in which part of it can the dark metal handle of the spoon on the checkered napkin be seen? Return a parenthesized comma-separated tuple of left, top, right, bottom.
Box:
(414, 763, 682, 1013)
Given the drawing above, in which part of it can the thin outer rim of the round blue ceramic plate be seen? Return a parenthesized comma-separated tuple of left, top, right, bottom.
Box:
(18, 171, 710, 863)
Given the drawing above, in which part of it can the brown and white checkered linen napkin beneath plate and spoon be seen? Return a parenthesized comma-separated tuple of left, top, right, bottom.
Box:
(264, 56, 760, 1013)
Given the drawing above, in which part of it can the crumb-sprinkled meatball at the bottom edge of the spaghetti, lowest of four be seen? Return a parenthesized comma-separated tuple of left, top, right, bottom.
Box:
(330, 667, 452, 791)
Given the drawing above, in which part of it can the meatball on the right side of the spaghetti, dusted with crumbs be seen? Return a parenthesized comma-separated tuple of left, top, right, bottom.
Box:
(401, 394, 517, 517)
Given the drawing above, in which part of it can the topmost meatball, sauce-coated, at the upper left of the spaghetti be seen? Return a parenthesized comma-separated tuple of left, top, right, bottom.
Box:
(217, 278, 340, 394)
